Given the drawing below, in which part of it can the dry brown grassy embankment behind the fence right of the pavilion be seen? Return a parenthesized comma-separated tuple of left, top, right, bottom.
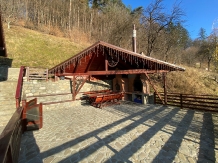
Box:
(152, 66, 218, 95)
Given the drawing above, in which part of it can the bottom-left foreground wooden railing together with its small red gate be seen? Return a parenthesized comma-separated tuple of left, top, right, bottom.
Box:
(0, 98, 42, 163)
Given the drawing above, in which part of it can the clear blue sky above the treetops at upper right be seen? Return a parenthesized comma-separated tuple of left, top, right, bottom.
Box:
(122, 0, 218, 39)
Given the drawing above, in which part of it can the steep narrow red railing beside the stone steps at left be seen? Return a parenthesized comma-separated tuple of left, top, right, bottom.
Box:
(15, 66, 25, 108)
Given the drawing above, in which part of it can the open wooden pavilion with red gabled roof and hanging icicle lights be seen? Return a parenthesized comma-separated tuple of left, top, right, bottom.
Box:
(49, 41, 185, 104)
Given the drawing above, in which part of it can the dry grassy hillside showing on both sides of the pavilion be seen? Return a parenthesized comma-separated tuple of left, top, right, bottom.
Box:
(4, 26, 218, 95)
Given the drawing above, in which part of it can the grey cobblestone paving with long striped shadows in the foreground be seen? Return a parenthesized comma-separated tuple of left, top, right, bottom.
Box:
(19, 103, 218, 163)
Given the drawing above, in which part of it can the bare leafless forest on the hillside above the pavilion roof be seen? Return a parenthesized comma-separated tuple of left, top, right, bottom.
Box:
(0, 0, 218, 71)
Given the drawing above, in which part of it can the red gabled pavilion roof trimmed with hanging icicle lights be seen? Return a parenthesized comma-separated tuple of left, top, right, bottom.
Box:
(49, 41, 185, 76)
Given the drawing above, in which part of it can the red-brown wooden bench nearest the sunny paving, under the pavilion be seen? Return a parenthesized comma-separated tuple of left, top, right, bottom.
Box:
(90, 92, 123, 108)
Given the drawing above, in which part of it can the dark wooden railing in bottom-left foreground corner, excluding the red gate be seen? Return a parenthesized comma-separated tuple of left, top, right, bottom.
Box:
(0, 107, 24, 163)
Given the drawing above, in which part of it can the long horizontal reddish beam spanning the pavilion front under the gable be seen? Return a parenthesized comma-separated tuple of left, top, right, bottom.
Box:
(56, 69, 169, 76)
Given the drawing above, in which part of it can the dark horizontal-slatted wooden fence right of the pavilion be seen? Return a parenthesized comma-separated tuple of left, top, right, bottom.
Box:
(154, 93, 218, 112)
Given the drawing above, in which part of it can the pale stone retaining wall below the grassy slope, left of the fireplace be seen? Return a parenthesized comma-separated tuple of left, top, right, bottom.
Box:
(22, 79, 111, 102)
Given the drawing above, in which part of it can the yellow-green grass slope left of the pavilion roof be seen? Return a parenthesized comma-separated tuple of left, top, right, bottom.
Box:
(4, 26, 88, 68)
